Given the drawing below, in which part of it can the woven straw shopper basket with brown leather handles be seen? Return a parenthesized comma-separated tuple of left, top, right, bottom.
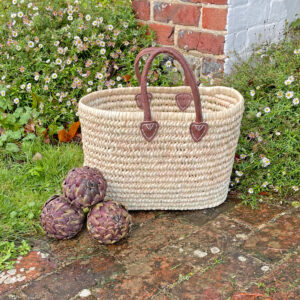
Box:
(79, 47, 244, 210)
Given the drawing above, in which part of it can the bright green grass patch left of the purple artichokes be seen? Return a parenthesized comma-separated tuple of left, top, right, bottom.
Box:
(0, 141, 83, 270)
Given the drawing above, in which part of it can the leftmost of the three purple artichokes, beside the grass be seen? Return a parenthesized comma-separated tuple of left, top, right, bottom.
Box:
(40, 195, 85, 240)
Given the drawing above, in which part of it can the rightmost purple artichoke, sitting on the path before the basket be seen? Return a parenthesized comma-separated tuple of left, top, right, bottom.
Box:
(87, 200, 132, 244)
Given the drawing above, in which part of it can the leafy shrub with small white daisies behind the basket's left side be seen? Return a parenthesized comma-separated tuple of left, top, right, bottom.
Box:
(0, 0, 180, 151)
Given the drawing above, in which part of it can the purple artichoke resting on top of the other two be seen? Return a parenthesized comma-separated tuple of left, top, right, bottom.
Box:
(63, 167, 107, 209)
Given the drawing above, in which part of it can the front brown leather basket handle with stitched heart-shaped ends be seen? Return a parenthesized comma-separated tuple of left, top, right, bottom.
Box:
(136, 47, 208, 142)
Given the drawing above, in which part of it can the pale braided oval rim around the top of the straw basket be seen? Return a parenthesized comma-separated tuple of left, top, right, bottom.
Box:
(79, 86, 244, 121)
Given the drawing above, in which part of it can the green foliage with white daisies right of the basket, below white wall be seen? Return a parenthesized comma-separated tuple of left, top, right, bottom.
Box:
(226, 33, 300, 206)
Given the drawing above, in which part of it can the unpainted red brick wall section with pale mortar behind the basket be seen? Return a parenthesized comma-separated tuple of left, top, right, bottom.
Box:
(132, 0, 227, 77)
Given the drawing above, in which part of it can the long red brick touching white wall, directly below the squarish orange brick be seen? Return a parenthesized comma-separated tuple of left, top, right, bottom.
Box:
(178, 30, 225, 55)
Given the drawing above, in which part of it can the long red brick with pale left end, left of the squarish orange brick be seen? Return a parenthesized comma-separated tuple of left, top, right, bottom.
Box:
(154, 2, 200, 26)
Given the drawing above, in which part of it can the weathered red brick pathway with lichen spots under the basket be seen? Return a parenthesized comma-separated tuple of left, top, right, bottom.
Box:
(0, 196, 300, 300)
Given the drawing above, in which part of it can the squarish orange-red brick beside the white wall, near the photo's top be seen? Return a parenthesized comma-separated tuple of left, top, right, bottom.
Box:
(202, 7, 227, 30)
